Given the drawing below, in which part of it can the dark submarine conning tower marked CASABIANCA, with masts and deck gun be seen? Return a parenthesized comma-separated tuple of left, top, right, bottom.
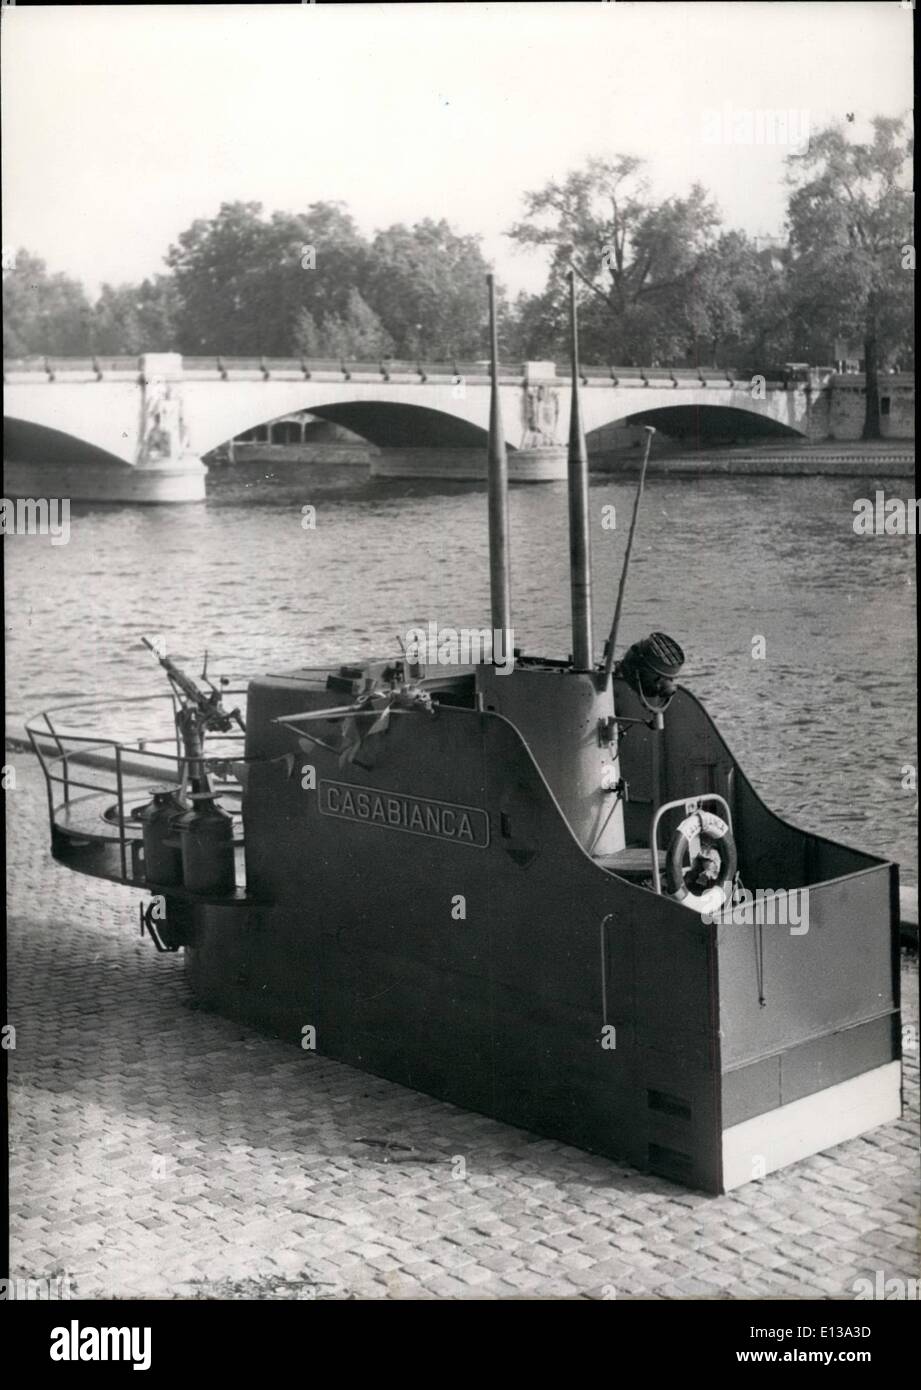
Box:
(31, 274, 900, 1193)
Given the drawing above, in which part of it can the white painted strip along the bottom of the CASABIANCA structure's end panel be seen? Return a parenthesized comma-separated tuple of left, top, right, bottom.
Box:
(722, 1062, 902, 1193)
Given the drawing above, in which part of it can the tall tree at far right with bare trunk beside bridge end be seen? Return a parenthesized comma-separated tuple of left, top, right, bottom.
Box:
(788, 117, 914, 439)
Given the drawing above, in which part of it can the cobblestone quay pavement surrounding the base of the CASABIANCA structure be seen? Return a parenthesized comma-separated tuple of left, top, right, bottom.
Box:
(7, 753, 918, 1298)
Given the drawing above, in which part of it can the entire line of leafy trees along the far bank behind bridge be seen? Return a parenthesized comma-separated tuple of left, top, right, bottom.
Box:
(3, 117, 914, 430)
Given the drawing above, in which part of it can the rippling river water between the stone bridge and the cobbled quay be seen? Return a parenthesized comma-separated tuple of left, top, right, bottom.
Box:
(3, 466, 917, 883)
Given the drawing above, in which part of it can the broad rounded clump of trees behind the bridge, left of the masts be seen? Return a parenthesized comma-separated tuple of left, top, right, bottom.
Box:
(167, 203, 497, 359)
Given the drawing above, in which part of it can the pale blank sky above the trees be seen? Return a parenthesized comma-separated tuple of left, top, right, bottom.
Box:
(3, 0, 911, 291)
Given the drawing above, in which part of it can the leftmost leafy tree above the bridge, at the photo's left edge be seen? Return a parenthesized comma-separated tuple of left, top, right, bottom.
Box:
(3, 250, 93, 357)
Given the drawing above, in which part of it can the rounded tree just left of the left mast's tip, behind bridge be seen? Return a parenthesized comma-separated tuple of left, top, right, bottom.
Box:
(365, 218, 501, 361)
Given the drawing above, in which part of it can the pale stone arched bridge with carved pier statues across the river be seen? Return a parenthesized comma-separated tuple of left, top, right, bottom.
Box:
(4, 353, 900, 502)
